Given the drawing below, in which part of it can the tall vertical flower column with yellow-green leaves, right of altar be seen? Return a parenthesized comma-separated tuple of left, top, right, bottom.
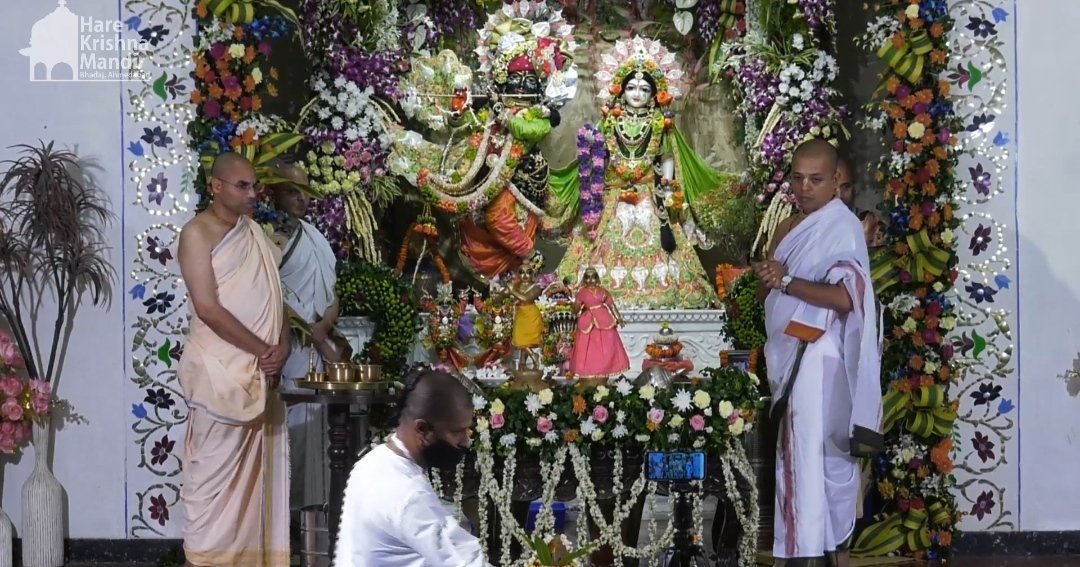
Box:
(853, 0, 963, 559)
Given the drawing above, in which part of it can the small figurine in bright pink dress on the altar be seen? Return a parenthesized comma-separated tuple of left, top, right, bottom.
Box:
(570, 268, 630, 379)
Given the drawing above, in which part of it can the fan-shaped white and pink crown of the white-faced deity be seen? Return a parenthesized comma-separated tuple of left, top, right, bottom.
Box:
(596, 36, 685, 105)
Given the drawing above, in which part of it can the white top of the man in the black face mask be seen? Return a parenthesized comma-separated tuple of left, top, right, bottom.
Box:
(334, 438, 490, 567)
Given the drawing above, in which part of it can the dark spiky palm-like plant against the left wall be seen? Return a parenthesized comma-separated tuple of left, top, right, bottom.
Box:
(0, 141, 116, 388)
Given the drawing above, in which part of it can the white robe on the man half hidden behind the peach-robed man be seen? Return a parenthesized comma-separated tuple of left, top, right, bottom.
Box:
(281, 220, 337, 510)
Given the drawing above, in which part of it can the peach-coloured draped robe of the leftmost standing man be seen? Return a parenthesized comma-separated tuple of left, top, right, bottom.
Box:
(178, 217, 289, 567)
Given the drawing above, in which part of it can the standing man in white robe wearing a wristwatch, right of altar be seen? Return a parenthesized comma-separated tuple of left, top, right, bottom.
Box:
(754, 140, 883, 567)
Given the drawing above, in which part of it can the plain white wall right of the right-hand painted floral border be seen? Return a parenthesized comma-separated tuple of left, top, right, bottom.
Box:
(1016, 0, 1080, 530)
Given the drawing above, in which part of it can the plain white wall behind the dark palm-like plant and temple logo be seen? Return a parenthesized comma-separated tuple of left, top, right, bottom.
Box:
(0, 0, 130, 538)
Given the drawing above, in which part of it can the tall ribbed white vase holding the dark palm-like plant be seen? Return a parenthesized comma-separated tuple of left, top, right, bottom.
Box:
(22, 417, 64, 567)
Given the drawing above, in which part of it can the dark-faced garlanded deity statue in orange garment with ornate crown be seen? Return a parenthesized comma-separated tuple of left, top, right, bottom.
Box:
(390, 0, 577, 280)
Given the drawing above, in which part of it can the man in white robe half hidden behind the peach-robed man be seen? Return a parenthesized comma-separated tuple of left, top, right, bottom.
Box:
(269, 161, 342, 510)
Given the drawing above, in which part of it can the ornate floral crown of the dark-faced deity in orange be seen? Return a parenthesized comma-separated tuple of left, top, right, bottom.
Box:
(476, 0, 578, 104)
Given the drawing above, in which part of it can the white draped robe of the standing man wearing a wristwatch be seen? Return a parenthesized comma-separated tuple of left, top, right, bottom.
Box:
(765, 200, 881, 558)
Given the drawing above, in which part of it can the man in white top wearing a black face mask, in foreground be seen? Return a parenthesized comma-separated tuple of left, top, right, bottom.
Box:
(335, 370, 490, 567)
